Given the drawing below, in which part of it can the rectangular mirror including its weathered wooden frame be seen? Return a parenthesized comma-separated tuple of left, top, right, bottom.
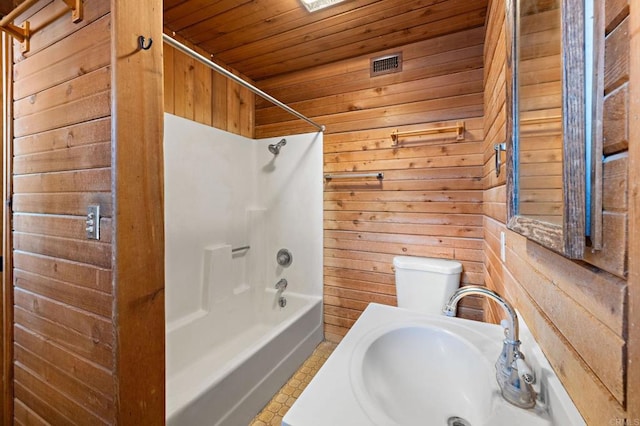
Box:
(506, 0, 586, 258)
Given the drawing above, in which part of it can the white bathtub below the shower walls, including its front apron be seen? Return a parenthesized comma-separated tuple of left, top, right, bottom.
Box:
(166, 289, 323, 426)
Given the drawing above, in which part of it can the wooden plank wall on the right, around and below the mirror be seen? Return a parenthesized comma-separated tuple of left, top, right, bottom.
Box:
(483, 0, 629, 424)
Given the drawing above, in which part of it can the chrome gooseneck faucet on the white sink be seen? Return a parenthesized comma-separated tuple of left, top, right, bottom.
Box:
(442, 285, 536, 408)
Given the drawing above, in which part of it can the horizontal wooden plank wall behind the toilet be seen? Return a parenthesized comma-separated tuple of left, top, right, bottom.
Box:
(256, 27, 484, 341)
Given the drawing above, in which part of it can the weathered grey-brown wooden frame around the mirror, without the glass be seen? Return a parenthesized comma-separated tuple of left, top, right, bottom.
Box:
(505, 0, 586, 259)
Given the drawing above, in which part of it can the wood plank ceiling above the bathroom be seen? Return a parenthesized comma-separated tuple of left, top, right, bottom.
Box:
(164, 0, 487, 81)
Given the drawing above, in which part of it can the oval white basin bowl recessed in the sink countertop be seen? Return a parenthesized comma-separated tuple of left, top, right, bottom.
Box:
(351, 324, 497, 425)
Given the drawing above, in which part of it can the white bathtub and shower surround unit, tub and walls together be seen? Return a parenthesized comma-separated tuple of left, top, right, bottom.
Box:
(164, 114, 322, 425)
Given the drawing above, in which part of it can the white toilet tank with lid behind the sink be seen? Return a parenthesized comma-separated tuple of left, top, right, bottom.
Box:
(393, 256, 462, 314)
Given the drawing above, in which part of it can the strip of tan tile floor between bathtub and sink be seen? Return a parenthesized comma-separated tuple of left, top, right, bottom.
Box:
(249, 342, 337, 426)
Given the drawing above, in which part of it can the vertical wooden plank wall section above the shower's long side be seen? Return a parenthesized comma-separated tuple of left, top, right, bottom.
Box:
(164, 39, 255, 138)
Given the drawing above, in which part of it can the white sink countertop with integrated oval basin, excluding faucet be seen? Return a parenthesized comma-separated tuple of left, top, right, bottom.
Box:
(283, 304, 584, 426)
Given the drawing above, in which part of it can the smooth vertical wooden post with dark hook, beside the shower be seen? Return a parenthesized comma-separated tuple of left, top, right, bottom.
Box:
(110, 0, 165, 425)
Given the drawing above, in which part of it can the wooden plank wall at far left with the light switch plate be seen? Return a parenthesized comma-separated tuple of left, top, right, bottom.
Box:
(6, 0, 117, 425)
